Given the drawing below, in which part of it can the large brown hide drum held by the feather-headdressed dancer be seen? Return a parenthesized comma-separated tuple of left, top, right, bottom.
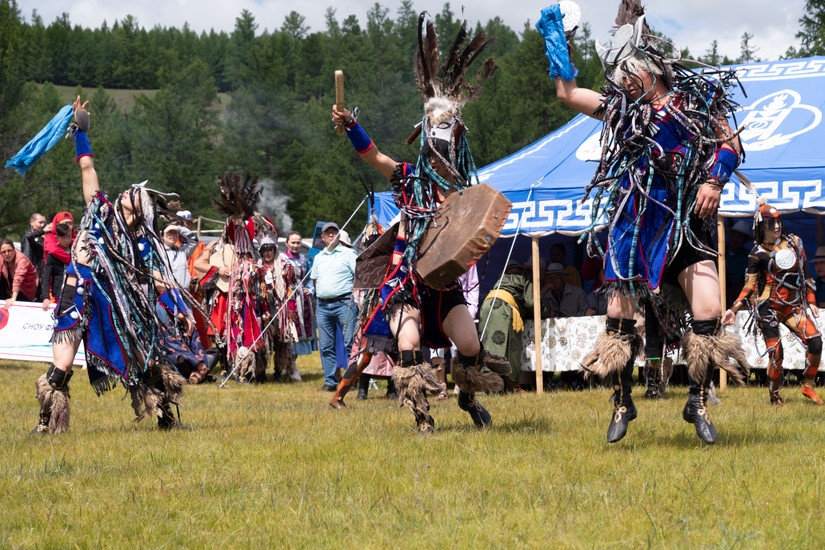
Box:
(416, 183, 513, 290)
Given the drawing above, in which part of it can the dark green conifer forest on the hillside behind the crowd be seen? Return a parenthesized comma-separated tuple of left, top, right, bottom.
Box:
(0, 0, 825, 236)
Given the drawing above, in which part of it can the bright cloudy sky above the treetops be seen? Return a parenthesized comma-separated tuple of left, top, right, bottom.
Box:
(18, 0, 805, 60)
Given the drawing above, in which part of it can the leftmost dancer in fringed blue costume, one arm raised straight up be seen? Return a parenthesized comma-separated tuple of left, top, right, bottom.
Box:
(32, 96, 200, 434)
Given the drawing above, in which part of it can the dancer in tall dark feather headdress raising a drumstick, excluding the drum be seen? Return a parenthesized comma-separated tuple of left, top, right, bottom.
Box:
(332, 13, 510, 435)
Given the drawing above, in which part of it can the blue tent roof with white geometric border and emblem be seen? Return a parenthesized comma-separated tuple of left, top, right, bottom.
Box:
(376, 56, 825, 237)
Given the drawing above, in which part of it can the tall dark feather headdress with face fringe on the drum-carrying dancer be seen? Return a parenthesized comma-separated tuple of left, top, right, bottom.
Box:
(407, 12, 496, 187)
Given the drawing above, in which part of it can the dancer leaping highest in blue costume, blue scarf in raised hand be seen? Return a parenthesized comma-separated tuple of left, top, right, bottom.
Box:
(537, 2, 747, 443)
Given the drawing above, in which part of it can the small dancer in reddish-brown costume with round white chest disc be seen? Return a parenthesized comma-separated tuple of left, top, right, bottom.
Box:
(724, 204, 822, 405)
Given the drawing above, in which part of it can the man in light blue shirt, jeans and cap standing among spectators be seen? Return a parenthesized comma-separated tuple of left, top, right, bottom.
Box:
(309, 223, 358, 392)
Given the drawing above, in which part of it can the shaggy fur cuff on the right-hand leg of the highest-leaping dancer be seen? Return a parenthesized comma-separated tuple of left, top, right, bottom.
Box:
(682, 330, 750, 386)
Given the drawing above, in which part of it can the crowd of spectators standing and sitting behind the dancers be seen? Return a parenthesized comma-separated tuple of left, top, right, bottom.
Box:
(6, 212, 825, 396)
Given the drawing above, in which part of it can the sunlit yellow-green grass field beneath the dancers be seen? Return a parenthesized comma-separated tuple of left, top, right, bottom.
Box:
(0, 356, 825, 549)
